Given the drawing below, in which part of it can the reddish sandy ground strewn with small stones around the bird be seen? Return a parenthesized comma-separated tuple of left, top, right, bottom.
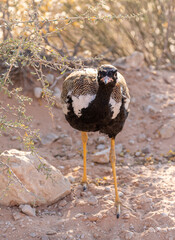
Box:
(0, 68, 175, 240)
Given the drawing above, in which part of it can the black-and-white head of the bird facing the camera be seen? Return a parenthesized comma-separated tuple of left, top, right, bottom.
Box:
(97, 64, 117, 87)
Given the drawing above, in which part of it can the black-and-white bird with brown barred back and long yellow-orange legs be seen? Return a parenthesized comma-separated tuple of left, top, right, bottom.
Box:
(61, 64, 130, 218)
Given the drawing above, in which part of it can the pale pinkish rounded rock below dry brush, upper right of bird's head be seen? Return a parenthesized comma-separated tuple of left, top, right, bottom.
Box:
(126, 51, 144, 69)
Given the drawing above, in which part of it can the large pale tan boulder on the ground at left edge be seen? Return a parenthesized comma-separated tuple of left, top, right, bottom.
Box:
(0, 149, 70, 206)
